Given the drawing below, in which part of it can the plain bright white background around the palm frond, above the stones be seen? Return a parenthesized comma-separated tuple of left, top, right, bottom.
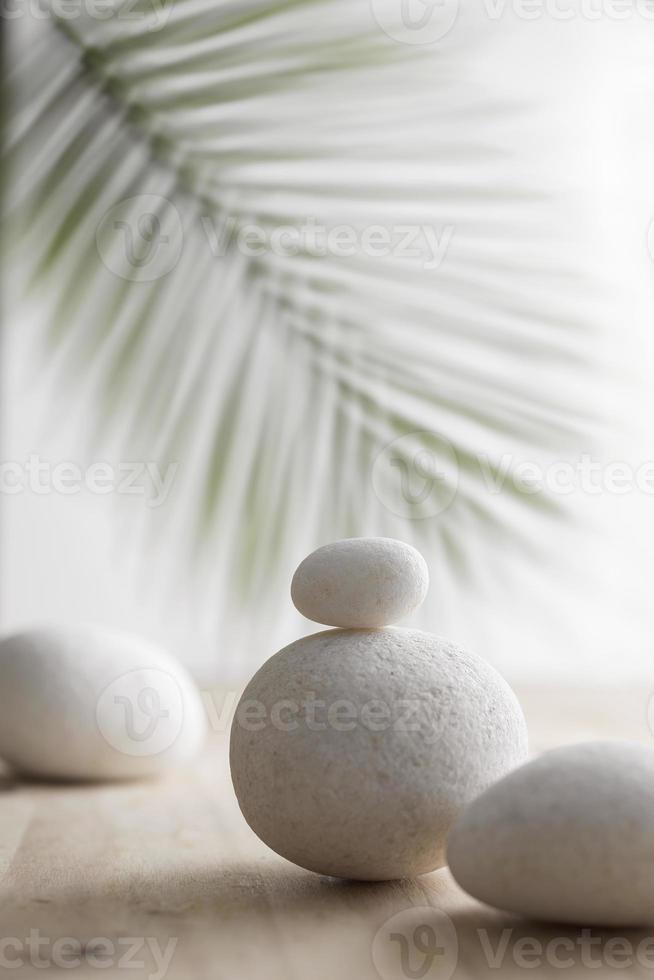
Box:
(1, 9, 654, 684)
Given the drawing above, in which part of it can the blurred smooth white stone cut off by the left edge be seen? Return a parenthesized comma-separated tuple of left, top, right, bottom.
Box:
(0, 627, 206, 780)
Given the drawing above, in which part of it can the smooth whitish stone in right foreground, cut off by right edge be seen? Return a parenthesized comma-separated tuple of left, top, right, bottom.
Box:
(448, 741, 654, 927)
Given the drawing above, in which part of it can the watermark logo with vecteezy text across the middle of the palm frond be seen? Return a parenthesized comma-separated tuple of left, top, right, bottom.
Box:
(96, 194, 455, 282)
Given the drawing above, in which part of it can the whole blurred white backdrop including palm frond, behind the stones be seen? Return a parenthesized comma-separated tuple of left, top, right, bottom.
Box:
(3, 0, 654, 679)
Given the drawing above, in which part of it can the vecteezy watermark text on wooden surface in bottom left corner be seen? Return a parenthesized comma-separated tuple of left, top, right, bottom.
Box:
(0, 929, 177, 980)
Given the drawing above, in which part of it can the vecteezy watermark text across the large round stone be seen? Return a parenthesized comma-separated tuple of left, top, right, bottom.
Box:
(228, 691, 448, 745)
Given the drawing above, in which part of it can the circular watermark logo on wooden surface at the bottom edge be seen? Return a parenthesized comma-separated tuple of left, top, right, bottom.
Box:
(372, 906, 459, 980)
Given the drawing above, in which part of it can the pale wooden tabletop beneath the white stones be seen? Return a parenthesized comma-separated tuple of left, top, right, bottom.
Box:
(0, 691, 654, 980)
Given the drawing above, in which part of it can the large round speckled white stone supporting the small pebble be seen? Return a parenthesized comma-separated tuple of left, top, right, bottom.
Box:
(230, 628, 527, 881)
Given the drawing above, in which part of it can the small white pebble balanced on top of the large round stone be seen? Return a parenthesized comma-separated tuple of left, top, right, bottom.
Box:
(291, 538, 429, 629)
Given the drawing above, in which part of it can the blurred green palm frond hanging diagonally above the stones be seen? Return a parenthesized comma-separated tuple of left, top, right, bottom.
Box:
(6, 0, 608, 656)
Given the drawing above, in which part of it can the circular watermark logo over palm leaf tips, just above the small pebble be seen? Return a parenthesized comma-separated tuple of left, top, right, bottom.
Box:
(371, 432, 459, 520)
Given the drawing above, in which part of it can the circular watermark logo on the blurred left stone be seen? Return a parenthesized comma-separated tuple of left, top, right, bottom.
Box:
(96, 668, 184, 756)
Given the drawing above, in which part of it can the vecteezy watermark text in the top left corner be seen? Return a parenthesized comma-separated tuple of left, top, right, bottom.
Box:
(0, 0, 174, 31)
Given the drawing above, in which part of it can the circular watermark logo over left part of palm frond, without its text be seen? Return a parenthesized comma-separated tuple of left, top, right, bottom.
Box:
(95, 194, 184, 282)
